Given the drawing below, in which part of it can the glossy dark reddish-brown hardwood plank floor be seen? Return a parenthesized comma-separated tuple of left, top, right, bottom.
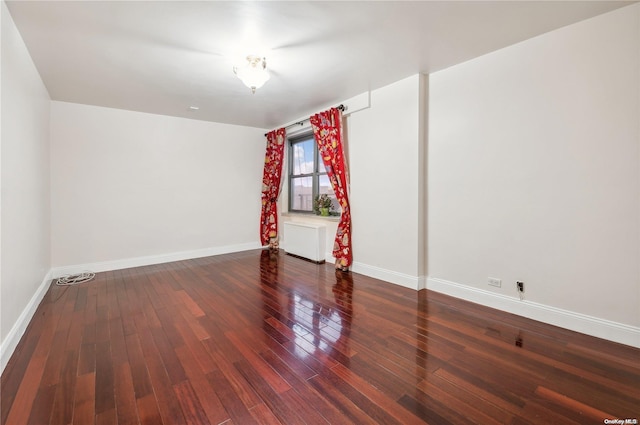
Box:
(1, 251, 640, 425)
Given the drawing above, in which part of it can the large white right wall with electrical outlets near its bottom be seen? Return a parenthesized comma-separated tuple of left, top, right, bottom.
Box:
(428, 4, 640, 338)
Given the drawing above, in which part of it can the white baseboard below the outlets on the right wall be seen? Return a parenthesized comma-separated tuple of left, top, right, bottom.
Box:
(427, 278, 640, 348)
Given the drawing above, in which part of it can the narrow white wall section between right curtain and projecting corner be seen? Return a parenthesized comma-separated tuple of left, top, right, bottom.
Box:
(348, 75, 422, 287)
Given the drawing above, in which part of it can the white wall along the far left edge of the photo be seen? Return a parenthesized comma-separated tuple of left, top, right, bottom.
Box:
(0, 2, 50, 362)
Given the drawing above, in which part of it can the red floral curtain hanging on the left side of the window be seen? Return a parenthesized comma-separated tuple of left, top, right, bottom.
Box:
(260, 128, 285, 249)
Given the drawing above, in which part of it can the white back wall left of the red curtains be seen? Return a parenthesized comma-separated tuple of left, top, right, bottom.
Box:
(51, 102, 265, 271)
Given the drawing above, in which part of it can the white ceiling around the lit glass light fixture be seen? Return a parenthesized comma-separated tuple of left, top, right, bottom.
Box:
(6, 1, 633, 128)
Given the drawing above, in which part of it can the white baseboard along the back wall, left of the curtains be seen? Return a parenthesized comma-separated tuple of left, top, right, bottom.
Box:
(51, 242, 262, 278)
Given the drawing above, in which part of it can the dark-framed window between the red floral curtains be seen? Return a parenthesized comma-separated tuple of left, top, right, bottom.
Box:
(289, 133, 340, 215)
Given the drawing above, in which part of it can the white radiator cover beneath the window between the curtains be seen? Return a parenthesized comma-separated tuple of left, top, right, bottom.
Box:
(283, 223, 326, 263)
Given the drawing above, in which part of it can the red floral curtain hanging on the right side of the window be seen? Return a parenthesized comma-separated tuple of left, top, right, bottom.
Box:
(310, 108, 353, 271)
